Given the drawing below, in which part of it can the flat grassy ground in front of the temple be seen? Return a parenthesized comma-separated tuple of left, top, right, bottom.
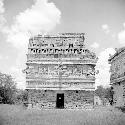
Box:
(0, 105, 125, 125)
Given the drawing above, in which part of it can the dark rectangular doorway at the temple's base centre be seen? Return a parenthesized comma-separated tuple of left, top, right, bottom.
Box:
(56, 93, 64, 109)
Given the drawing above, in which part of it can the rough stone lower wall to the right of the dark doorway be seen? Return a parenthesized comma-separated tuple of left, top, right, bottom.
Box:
(64, 90, 94, 109)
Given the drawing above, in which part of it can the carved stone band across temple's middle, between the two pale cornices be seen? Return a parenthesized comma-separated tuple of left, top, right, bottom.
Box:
(25, 65, 95, 78)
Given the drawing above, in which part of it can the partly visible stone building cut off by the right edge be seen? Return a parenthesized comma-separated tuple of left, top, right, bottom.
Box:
(109, 47, 125, 106)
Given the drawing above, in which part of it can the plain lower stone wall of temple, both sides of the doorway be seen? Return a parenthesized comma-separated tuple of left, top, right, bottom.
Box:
(28, 89, 94, 109)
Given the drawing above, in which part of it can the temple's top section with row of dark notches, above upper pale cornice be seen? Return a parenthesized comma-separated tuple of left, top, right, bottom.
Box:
(27, 34, 96, 63)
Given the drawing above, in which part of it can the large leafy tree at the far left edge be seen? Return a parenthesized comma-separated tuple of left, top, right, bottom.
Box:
(0, 73, 16, 104)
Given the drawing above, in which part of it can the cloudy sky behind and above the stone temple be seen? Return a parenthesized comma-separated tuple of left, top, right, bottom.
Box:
(0, 0, 125, 87)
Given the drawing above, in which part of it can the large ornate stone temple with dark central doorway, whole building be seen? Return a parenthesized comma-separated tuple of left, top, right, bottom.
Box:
(25, 33, 97, 109)
